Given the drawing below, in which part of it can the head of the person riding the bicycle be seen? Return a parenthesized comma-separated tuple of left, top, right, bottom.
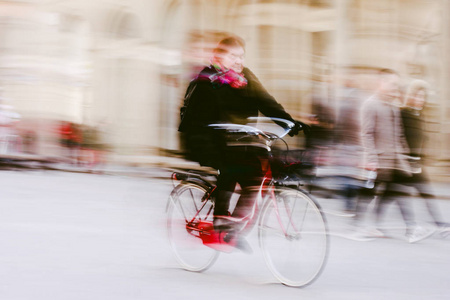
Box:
(213, 36, 245, 73)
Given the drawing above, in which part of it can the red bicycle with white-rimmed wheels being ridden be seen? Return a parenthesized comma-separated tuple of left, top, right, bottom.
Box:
(167, 118, 329, 287)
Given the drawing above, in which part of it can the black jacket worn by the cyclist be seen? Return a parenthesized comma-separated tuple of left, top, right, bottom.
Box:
(178, 66, 294, 168)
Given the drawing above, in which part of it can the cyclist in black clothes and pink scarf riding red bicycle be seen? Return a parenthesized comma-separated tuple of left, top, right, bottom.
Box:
(179, 36, 309, 251)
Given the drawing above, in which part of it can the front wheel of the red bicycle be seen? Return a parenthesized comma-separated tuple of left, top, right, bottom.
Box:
(258, 188, 328, 287)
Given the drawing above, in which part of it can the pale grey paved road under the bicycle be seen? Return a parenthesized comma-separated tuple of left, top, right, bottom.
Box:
(0, 171, 450, 300)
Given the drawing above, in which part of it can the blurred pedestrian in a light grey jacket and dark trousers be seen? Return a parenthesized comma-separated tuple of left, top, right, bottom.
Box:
(355, 69, 433, 243)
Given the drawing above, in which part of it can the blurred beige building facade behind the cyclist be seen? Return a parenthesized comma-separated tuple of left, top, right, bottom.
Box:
(0, 0, 450, 173)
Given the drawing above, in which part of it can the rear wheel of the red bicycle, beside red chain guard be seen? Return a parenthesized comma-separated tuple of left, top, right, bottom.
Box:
(167, 182, 219, 272)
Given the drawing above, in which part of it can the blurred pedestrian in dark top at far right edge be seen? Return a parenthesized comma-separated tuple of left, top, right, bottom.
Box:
(401, 80, 450, 234)
